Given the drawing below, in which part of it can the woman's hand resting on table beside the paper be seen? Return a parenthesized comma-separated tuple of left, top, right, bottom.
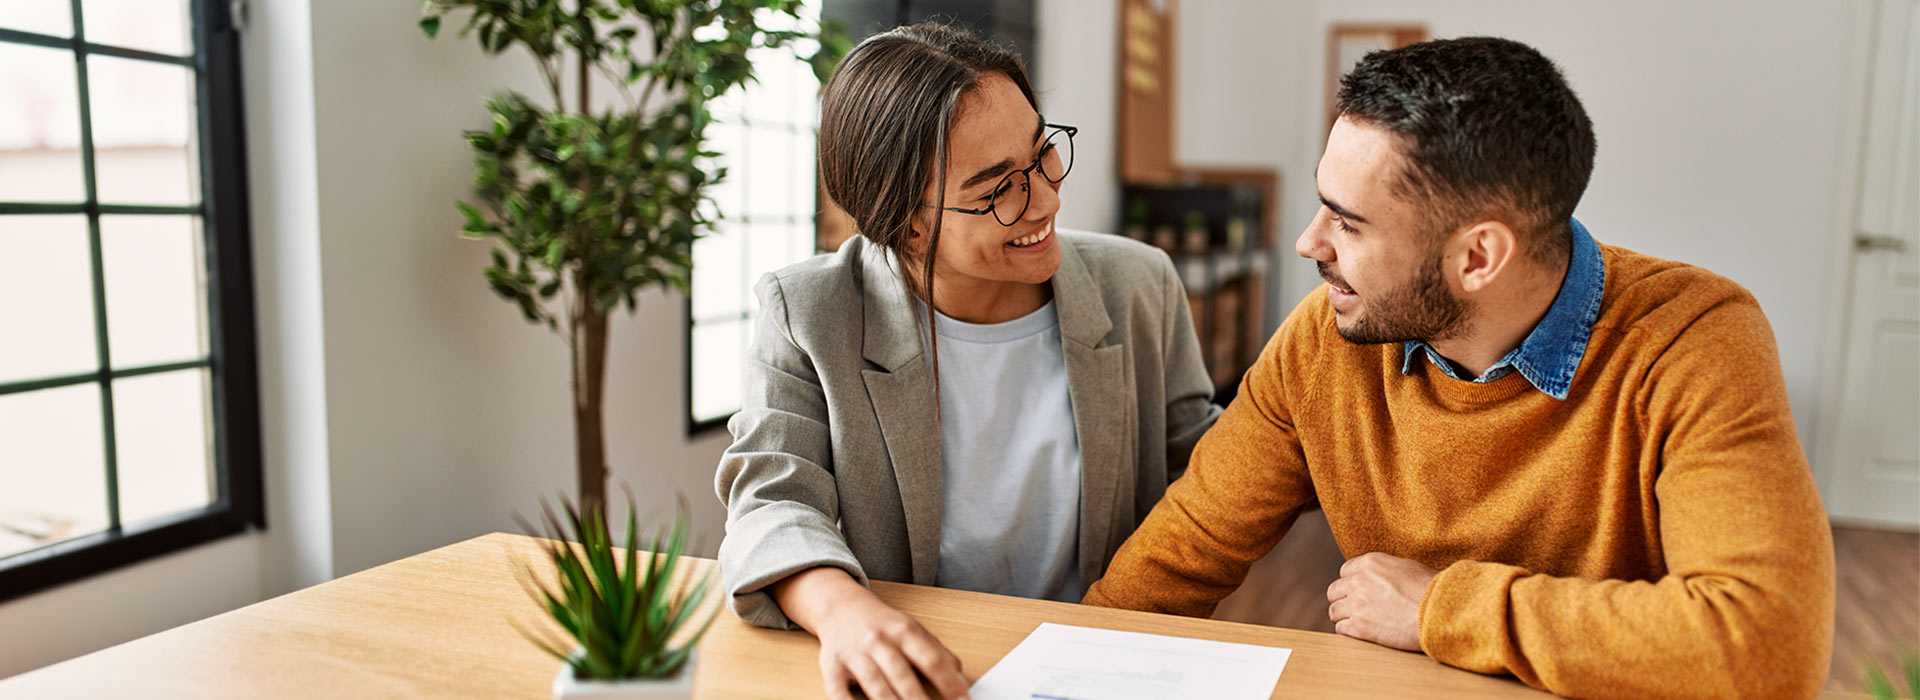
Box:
(770, 566, 968, 700)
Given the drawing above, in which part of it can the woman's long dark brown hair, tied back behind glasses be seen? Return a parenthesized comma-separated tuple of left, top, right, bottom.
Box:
(820, 23, 1039, 308)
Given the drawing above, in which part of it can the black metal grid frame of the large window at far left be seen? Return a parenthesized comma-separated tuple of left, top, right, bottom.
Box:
(0, 0, 267, 602)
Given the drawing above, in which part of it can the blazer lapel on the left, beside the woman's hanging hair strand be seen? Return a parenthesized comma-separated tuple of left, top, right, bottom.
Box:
(860, 244, 941, 585)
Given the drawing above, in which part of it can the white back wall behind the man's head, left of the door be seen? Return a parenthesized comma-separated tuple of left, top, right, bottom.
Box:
(1039, 0, 1847, 455)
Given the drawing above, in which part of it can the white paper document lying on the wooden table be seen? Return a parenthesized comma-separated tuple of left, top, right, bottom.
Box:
(972, 623, 1292, 700)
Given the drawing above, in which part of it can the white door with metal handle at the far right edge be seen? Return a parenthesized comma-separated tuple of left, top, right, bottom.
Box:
(1822, 0, 1920, 527)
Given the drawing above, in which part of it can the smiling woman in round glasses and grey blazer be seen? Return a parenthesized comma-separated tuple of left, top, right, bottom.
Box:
(716, 25, 1219, 698)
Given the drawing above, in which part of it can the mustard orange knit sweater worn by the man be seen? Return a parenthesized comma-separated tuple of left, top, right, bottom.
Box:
(1085, 247, 1834, 698)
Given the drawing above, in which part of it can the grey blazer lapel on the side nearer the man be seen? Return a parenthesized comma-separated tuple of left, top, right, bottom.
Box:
(1054, 238, 1135, 585)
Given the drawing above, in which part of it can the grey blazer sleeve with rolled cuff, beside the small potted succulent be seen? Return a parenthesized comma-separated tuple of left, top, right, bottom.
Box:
(714, 274, 868, 629)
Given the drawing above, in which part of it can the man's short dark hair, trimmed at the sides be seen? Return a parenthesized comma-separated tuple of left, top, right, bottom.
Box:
(1338, 36, 1594, 265)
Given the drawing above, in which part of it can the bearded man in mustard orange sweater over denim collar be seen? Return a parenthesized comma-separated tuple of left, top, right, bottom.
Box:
(1085, 38, 1834, 698)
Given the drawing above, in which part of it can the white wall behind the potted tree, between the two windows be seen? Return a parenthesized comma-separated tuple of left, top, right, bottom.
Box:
(313, 0, 726, 575)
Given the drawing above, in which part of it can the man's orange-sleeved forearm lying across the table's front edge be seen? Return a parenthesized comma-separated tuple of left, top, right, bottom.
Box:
(1419, 562, 1832, 698)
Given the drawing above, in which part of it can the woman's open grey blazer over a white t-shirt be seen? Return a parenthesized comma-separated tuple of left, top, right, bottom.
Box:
(714, 230, 1219, 629)
